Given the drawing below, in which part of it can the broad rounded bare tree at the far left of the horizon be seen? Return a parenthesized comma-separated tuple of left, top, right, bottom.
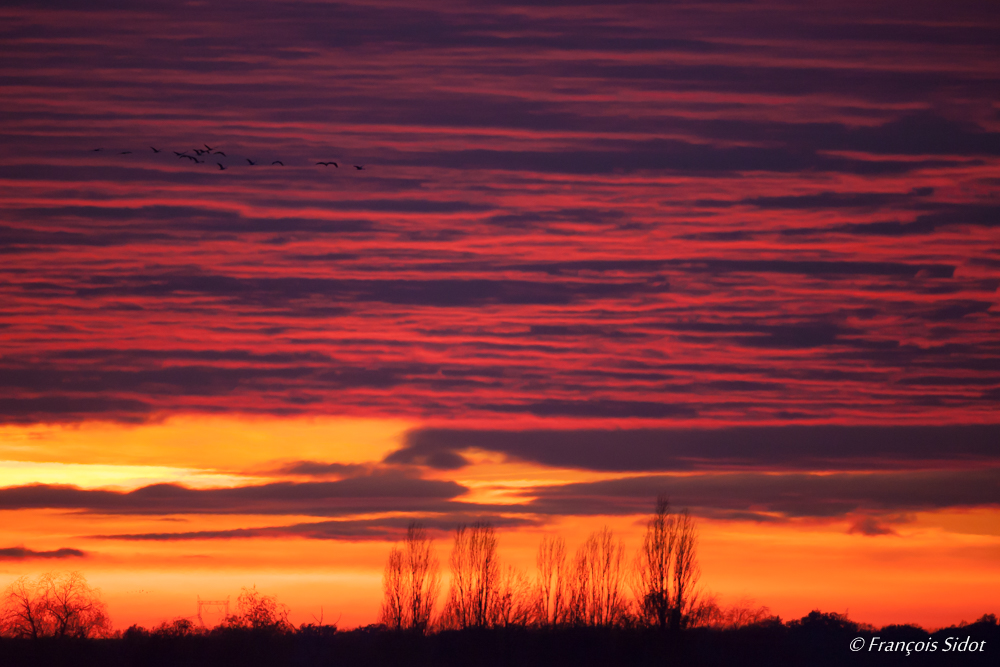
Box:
(2, 572, 111, 639)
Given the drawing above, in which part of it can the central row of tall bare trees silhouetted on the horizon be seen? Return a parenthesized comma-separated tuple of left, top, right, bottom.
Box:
(379, 498, 752, 632)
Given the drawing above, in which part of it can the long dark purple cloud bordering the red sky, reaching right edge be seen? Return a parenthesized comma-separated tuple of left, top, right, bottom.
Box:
(386, 425, 1000, 472)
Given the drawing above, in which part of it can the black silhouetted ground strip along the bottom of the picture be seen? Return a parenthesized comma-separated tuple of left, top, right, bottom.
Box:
(0, 612, 1000, 667)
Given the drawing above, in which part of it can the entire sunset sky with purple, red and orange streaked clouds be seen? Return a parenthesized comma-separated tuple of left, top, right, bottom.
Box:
(0, 0, 1000, 627)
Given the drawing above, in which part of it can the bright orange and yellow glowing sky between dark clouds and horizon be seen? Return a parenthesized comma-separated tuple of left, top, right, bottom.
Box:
(0, 418, 1000, 627)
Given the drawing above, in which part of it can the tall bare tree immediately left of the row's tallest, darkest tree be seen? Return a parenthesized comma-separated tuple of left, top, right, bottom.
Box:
(571, 526, 628, 625)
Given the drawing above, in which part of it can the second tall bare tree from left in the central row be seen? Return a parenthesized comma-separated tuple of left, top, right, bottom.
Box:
(444, 522, 500, 628)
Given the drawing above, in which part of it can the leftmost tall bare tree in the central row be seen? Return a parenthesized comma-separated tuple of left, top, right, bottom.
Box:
(380, 523, 441, 632)
